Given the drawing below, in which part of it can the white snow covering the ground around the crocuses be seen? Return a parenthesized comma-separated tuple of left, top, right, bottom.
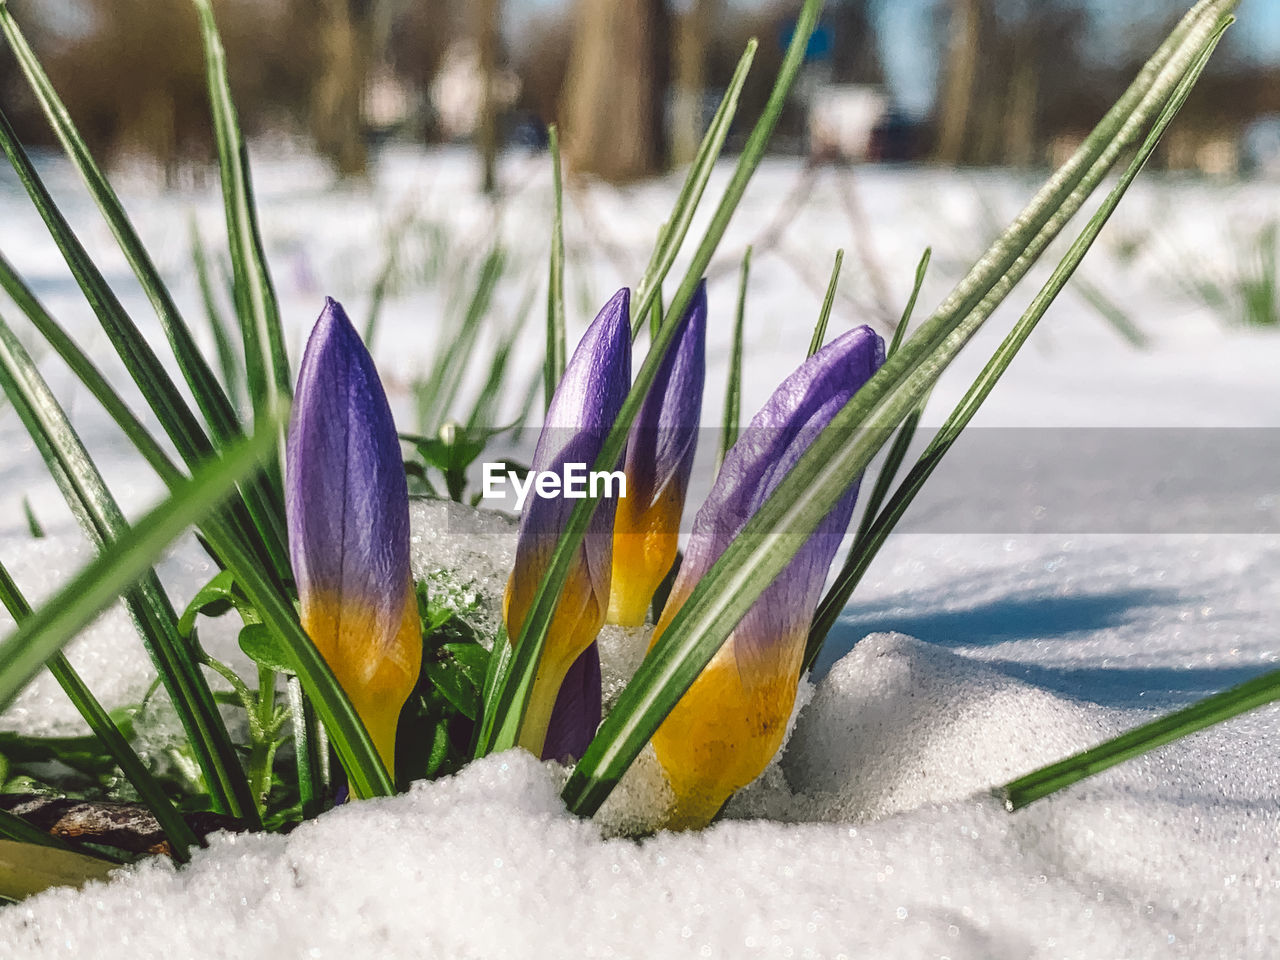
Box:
(0, 151, 1280, 960)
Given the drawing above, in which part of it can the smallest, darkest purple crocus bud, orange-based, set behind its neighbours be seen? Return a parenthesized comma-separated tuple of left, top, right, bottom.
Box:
(608, 280, 707, 627)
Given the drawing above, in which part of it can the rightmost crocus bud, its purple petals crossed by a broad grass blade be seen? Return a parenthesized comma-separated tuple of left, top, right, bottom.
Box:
(650, 326, 884, 828)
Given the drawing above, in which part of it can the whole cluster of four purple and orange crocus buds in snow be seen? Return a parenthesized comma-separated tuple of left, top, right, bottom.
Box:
(287, 285, 884, 828)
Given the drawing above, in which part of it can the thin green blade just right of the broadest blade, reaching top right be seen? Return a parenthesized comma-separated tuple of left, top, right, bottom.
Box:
(804, 20, 1228, 669)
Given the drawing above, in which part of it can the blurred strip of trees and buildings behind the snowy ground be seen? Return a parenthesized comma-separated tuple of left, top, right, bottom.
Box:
(0, 0, 1280, 191)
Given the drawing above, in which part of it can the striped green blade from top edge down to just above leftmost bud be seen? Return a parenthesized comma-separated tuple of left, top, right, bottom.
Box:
(192, 0, 292, 419)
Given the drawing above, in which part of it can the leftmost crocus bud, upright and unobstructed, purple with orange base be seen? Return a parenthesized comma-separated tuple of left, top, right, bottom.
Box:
(285, 298, 422, 773)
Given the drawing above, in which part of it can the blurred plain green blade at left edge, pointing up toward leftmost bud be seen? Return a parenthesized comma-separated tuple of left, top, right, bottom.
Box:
(0, 424, 275, 709)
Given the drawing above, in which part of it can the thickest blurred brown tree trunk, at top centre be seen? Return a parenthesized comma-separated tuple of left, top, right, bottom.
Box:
(563, 0, 669, 182)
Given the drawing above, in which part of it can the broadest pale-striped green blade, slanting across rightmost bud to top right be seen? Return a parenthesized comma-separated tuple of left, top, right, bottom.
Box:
(558, 4, 1229, 815)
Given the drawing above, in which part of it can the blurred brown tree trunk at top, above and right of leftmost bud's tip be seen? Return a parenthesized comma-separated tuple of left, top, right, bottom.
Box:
(311, 0, 374, 177)
